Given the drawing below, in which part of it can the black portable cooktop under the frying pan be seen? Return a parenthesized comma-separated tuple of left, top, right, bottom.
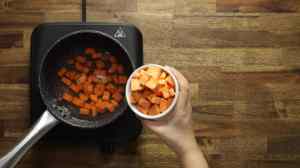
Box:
(31, 23, 143, 149)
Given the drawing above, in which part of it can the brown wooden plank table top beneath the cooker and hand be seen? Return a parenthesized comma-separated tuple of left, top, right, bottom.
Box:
(0, 0, 300, 168)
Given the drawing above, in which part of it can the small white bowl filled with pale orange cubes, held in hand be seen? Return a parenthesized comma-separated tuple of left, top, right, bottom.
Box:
(126, 64, 179, 119)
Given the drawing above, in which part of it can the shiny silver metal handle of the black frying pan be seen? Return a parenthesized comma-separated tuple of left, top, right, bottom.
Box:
(0, 110, 59, 168)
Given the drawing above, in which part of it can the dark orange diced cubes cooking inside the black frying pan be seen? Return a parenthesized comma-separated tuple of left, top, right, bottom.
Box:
(57, 48, 128, 117)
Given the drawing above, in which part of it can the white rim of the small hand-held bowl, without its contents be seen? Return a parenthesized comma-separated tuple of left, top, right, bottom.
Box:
(126, 64, 179, 120)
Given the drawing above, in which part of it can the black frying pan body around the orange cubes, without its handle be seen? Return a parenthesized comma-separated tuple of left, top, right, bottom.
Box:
(39, 32, 133, 128)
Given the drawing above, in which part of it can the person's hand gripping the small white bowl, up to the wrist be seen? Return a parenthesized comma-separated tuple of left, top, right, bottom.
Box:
(143, 67, 197, 155)
